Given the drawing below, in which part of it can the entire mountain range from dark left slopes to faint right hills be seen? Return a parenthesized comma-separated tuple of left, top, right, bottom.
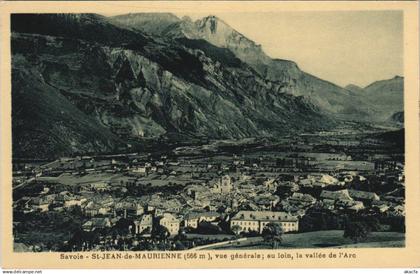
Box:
(11, 14, 403, 158)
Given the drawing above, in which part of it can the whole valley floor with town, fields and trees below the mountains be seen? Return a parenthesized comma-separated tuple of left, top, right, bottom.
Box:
(13, 127, 405, 251)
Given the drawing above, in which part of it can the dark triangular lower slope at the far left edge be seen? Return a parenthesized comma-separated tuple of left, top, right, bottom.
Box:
(12, 52, 122, 158)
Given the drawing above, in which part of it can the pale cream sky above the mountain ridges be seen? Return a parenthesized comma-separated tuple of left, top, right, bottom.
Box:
(176, 11, 403, 87)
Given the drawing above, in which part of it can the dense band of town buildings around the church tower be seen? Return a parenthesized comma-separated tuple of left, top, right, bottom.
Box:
(15, 166, 405, 239)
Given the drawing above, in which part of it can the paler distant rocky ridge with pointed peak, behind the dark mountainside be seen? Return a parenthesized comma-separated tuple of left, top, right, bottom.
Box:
(112, 14, 376, 120)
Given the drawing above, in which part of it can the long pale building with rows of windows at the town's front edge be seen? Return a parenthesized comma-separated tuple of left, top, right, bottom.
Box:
(230, 211, 299, 233)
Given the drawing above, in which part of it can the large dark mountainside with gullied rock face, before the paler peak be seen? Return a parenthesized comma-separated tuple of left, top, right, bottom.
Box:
(12, 14, 336, 157)
